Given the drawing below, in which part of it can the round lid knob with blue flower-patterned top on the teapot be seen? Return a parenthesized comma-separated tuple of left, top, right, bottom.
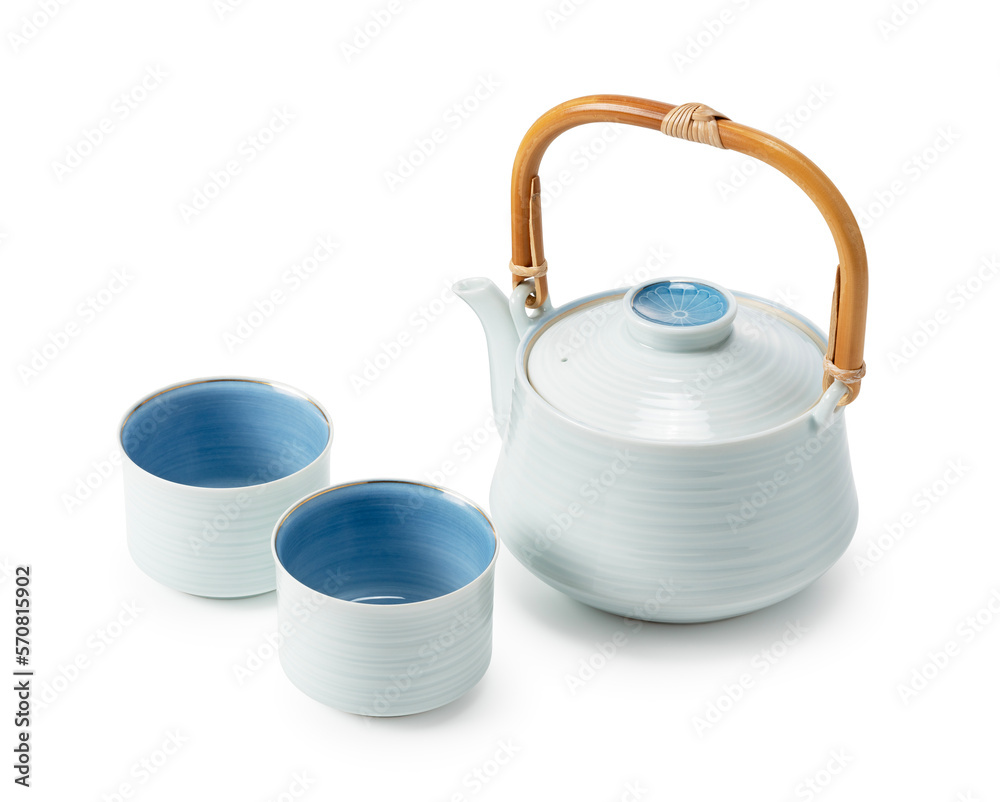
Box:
(623, 278, 737, 351)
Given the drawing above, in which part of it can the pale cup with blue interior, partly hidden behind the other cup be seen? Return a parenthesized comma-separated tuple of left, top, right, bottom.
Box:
(119, 377, 333, 598)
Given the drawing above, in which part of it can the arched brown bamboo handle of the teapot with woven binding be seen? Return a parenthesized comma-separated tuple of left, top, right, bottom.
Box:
(510, 95, 868, 404)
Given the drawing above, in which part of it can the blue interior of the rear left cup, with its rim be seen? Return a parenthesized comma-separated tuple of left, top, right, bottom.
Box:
(121, 379, 330, 487)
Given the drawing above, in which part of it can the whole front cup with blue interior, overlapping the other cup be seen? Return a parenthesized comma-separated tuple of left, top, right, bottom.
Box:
(273, 480, 497, 716)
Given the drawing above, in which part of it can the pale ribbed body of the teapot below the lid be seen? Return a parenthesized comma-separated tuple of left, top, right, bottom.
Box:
(490, 375, 858, 622)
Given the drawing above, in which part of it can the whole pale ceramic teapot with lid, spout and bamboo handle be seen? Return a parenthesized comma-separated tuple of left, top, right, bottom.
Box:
(455, 95, 867, 622)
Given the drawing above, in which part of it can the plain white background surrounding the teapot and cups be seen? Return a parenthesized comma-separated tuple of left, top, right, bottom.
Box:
(0, 0, 1000, 801)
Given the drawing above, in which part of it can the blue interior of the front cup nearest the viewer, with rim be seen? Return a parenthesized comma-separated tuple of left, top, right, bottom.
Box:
(274, 481, 496, 604)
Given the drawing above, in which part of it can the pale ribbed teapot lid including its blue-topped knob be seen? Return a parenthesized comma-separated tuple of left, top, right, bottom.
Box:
(524, 278, 826, 443)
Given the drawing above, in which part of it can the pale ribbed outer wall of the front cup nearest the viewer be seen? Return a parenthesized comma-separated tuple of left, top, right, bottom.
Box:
(277, 561, 496, 716)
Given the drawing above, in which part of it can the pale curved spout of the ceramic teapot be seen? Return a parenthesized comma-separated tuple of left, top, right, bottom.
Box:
(452, 278, 519, 434)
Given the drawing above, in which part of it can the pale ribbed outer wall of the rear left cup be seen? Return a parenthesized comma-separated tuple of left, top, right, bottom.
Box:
(122, 449, 330, 598)
